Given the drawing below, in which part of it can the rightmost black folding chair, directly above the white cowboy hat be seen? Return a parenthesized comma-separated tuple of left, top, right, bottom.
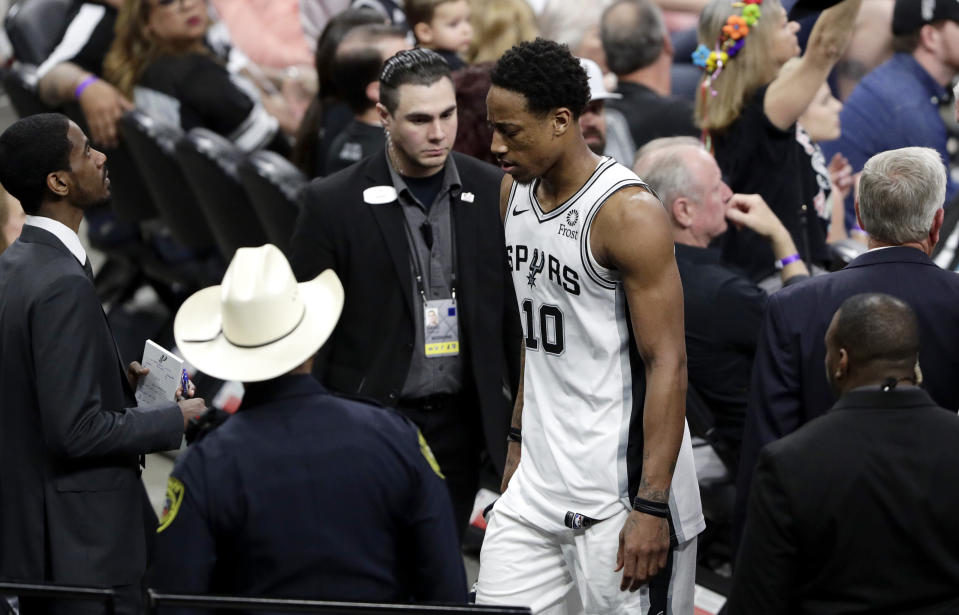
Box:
(239, 150, 307, 252)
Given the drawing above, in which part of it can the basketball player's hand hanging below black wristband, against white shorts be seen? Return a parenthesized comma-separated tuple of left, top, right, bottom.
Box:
(615, 510, 669, 592)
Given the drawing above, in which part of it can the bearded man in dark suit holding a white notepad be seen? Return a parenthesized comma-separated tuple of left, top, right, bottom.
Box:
(0, 114, 203, 615)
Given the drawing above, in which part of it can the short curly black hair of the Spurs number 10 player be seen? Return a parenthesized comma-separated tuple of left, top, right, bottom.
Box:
(490, 38, 590, 118)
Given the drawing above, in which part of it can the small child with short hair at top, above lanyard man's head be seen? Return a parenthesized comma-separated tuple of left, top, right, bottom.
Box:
(405, 0, 473, 70)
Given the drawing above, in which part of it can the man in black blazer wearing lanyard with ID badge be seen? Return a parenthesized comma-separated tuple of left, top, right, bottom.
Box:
(290, 49, 521, 532)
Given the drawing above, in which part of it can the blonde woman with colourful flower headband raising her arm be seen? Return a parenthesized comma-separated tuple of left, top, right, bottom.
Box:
(695, 0, 861, 281)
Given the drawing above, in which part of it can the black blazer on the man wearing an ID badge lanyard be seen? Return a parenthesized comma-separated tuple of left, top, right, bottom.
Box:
(290, 149, 522, 471)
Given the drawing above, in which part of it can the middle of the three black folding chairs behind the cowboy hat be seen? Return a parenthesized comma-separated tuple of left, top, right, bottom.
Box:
(176, 128, 268, 262)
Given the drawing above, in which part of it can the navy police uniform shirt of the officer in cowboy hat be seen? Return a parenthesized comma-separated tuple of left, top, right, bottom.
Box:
(153, 375, 466, 602)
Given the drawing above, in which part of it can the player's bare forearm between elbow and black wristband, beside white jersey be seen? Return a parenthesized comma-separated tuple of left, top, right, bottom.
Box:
(636, 345, 686, 502)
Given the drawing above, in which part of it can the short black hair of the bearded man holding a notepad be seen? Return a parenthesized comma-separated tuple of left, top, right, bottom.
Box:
(0, 113, 72, 215)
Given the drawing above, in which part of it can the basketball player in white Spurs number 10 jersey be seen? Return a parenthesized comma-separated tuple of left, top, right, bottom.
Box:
(476, 39, 705, 615)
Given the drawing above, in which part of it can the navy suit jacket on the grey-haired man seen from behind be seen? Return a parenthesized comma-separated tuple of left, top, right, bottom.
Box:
(736, 247, 959, 544)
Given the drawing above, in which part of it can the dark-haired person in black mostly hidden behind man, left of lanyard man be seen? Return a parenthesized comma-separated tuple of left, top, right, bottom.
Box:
(290, 9, 387, 178)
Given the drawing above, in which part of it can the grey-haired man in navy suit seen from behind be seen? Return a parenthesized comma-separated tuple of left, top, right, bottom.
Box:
(737, 147, 959, 544)
